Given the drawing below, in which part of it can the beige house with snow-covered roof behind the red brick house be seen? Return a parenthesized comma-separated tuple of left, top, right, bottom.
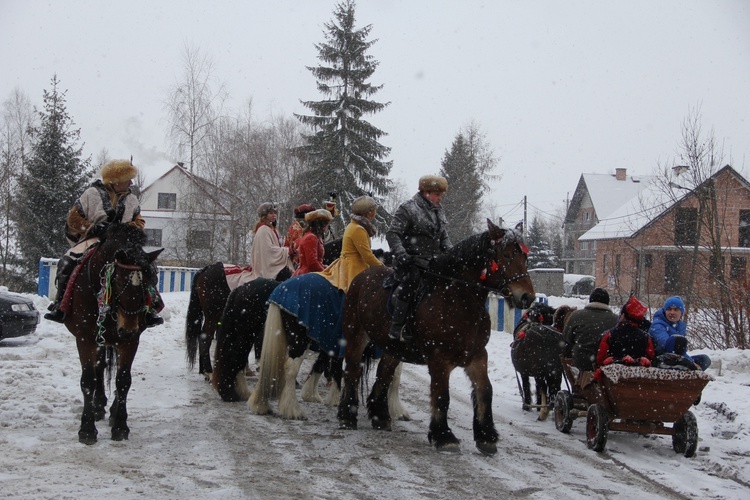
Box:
(562, 168, 650, 276)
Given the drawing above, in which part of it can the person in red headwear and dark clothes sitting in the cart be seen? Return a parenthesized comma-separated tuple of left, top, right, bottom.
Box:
(596, 296, 654, 366)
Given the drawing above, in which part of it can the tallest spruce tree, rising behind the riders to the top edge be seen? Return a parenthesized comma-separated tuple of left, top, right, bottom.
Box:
(295, 0, 393, 232)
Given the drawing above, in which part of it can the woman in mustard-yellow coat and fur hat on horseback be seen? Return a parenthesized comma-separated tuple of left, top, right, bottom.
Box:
(320, 196, 383, 293)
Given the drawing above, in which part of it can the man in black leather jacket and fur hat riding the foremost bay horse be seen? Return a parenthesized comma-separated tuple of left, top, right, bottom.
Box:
(385, 175, 453, 341)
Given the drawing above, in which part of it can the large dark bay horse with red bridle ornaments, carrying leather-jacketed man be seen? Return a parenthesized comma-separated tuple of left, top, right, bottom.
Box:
(338, 219, 535, 455)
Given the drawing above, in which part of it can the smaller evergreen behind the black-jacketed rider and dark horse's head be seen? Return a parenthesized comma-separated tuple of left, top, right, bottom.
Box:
(440, 124, 499, 243)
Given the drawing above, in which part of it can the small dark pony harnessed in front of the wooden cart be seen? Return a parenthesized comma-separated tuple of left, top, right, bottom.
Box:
(510, 303, 576, 421)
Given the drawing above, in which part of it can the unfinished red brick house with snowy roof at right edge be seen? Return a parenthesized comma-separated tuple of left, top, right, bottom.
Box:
(579, 165, 750, 307)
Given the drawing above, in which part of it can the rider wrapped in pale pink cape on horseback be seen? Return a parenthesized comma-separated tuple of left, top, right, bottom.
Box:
(250, 202, 293, 281)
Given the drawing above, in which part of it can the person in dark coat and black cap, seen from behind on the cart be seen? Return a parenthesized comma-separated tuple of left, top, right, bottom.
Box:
(563, 288, 617, 371)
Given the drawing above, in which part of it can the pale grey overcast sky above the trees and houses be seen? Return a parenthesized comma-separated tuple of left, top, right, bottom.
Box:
(0, 0, 750, 223)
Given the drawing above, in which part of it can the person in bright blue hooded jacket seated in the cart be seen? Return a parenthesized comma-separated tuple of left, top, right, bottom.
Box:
(648, 296, 711, 370)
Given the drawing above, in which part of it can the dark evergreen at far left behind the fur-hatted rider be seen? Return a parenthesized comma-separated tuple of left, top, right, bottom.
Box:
(15, 75, 93, 289)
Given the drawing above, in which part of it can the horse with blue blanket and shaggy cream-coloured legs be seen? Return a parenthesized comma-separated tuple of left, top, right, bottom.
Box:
(247, 273, 411, 420)
